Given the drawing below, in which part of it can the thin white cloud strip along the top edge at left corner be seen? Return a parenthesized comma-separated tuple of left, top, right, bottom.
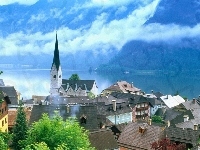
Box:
(0, 0, 39, 5)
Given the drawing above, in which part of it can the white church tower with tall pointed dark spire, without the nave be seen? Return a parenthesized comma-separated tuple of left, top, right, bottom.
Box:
(50, 33, 62, 96)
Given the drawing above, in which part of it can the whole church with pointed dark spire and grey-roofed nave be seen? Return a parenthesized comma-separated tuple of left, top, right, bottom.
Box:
(50, 33, 98, 96)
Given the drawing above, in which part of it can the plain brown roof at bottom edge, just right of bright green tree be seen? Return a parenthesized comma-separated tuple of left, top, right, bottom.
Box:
(89, 130, 118, 150)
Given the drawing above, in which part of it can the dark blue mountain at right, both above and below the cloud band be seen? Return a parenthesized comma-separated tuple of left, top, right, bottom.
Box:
(98, 0, 200, 73)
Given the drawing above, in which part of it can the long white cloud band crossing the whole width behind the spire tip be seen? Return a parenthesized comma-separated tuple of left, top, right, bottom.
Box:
(0, 0, 200, 55)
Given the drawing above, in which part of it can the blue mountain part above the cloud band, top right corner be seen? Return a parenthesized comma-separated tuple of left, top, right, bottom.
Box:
(146, 0, 200, 26)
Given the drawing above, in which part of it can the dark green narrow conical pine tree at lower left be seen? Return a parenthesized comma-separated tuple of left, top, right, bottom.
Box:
(12, 102, 28, 150)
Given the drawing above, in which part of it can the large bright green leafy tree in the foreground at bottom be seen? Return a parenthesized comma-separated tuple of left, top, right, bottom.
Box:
(22, 114, 93, 150)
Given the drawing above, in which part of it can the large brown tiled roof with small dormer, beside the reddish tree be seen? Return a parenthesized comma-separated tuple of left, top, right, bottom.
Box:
(118, 123, 164, 150)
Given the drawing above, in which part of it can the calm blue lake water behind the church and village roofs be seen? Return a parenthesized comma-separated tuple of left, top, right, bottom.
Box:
(0, 69, 200, 99)
